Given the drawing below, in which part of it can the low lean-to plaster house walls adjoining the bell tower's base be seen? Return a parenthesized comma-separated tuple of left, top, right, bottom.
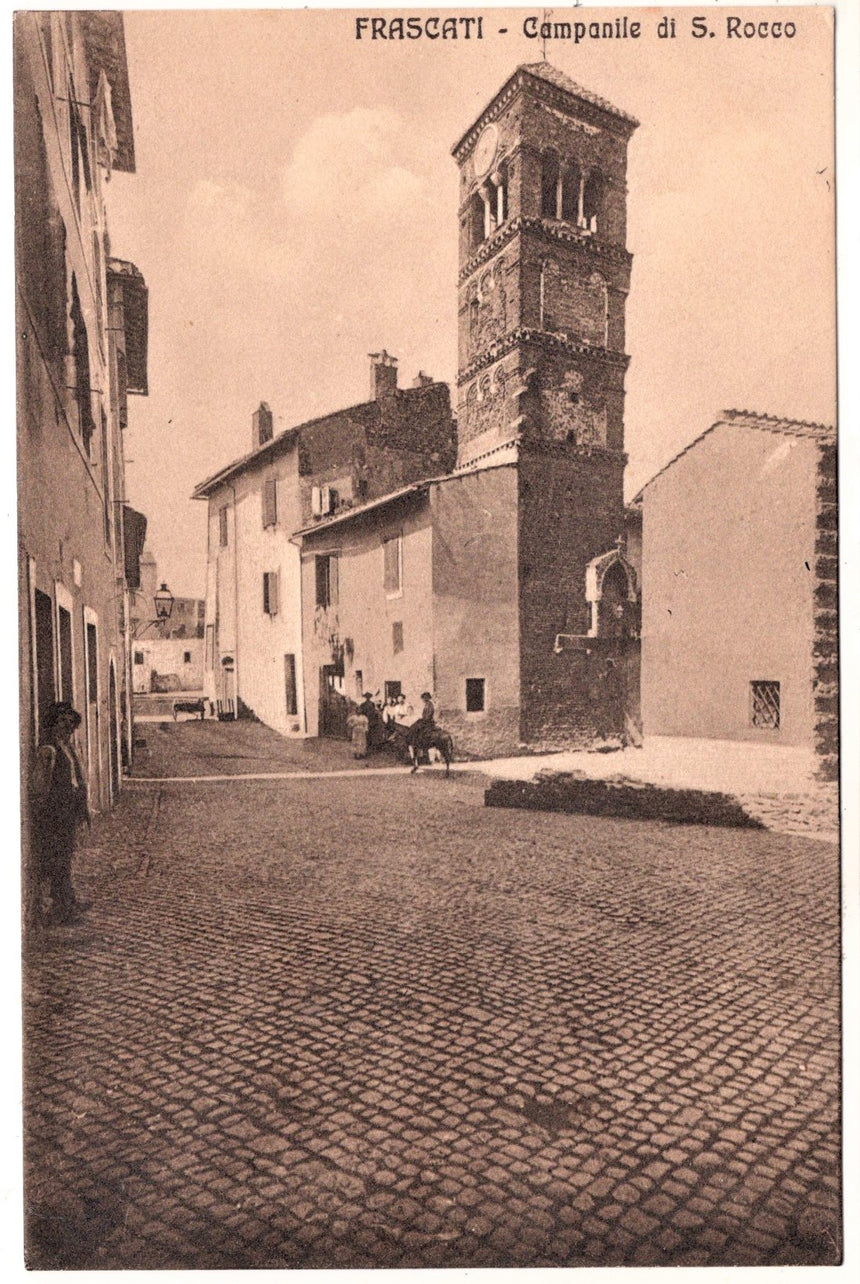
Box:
(302, 464, 520, 754)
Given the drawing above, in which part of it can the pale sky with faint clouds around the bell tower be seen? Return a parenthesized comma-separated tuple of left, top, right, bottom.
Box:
(108, 5, 836, 596)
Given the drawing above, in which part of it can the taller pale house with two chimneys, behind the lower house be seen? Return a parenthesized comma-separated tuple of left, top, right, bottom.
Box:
(195, 367, 456, 736)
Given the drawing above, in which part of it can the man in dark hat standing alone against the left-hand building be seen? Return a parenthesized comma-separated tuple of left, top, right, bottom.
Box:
(31, 700, 90, 923)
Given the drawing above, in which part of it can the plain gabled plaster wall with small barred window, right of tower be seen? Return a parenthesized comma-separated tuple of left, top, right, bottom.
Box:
(641, 413, 836, 751)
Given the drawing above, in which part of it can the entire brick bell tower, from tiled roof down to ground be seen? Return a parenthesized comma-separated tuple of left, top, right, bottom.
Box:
(453, 70, 638, 741)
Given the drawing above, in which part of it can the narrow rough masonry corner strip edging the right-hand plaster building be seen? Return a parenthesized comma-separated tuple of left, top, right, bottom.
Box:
(813, 446, 839, 781)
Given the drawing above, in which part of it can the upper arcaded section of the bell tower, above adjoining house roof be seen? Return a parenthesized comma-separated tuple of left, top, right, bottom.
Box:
(453, 63, 637, 464)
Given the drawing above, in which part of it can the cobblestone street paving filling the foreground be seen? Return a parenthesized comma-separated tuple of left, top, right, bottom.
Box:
(24, 741, 841, 1269)
